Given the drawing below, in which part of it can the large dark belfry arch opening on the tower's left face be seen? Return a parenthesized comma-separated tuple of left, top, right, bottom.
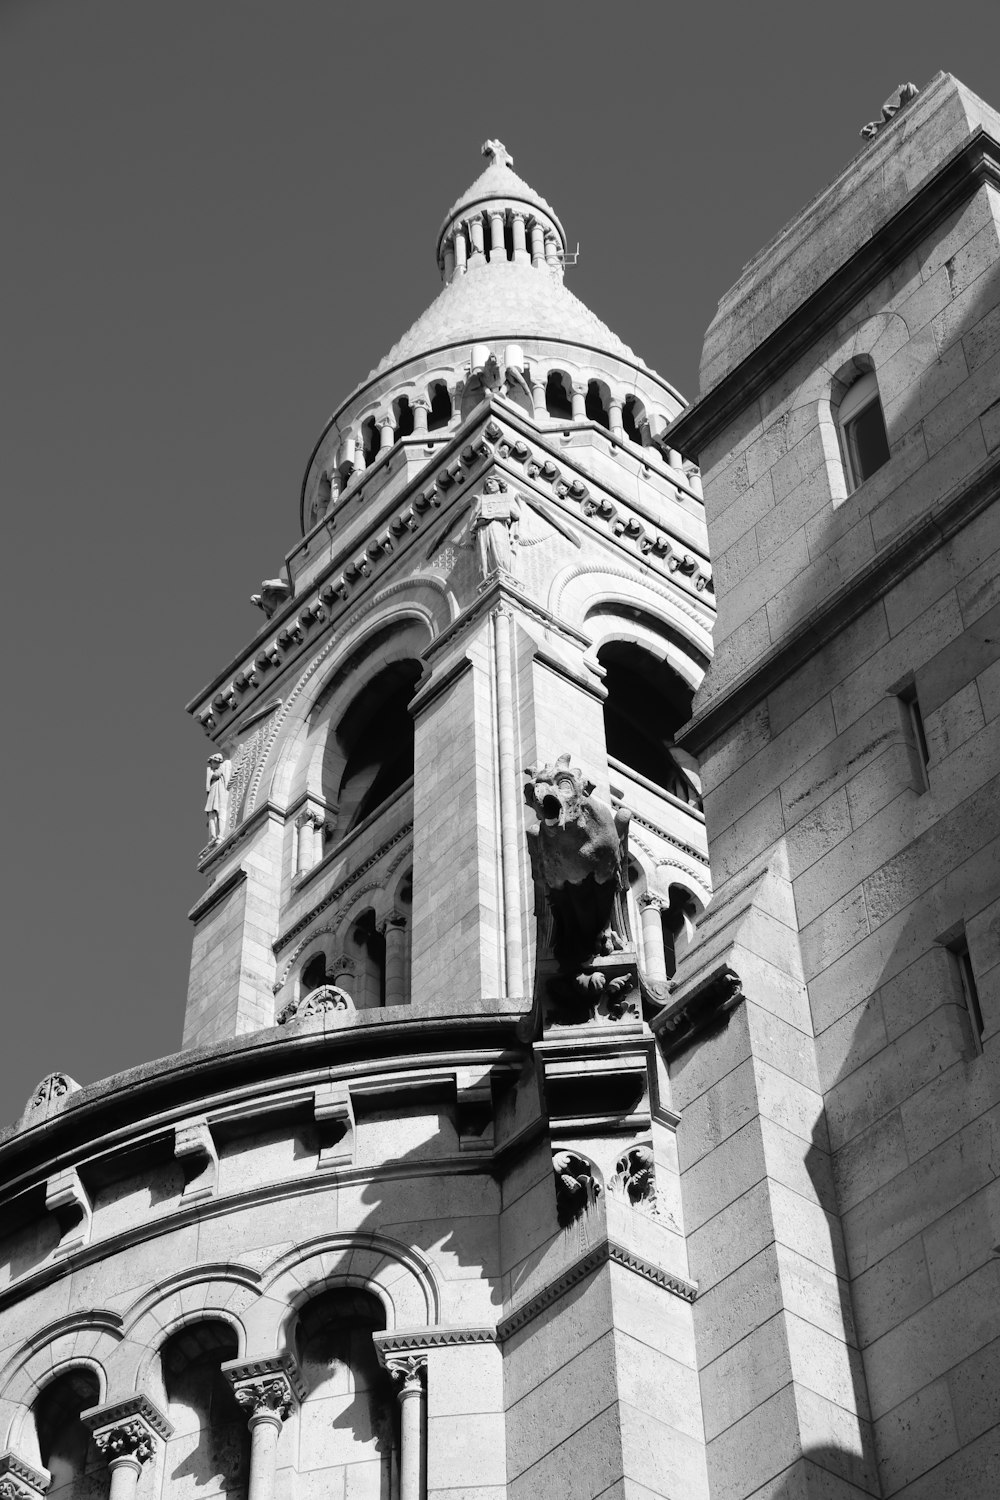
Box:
(330, 660, 421, 839)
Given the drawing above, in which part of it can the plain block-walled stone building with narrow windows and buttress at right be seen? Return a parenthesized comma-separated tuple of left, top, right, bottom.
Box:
(672, 74, 1000, 1500)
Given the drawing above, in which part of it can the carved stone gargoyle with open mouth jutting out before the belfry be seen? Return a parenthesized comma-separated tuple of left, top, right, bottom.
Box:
(525, 755, 628, 974)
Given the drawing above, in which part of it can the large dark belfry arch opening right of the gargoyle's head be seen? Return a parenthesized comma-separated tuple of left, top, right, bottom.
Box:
(597, 641, 702, 809)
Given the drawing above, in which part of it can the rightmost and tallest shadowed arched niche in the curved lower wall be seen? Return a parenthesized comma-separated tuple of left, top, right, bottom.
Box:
(294, 1287, 399, 1500)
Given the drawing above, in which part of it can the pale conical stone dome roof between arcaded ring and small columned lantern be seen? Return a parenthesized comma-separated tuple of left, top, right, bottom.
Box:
(366, 255, 643, 384)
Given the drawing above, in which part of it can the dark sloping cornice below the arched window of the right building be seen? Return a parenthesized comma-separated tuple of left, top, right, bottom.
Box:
(676, 438, 1000, 756)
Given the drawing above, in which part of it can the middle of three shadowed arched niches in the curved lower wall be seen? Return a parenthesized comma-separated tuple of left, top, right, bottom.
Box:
(160, 1319, 250, 1494)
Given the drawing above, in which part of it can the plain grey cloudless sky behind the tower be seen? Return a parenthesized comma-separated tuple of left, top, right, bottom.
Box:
(0, 0, 1000, 1121)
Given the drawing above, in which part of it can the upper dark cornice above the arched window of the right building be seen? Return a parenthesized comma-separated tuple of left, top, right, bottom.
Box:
(669, 126, 1000, 458)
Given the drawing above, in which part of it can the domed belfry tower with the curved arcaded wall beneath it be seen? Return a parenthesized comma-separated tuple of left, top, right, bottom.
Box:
(0, 141, 719, 1500)
